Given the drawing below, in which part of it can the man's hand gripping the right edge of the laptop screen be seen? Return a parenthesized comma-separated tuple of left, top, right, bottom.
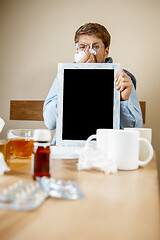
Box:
(115, 69, 133, 101)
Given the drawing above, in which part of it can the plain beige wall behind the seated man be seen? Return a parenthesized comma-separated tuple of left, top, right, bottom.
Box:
(0, 0, 160, 184)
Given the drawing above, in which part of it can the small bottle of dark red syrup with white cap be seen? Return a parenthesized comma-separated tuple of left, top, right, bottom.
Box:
(32, 129, 51, 179)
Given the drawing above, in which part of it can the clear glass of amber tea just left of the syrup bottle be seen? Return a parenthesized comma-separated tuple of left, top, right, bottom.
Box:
(7, 129, 33, 158)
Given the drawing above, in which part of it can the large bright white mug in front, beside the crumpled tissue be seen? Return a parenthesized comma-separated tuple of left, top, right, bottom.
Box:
(86, 129, 153, 170)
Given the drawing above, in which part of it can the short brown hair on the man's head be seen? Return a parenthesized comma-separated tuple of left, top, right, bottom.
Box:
(74, 23, 111, 47)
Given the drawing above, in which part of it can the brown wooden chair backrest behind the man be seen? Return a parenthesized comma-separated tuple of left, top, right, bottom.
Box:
(10, 100, 146, 124)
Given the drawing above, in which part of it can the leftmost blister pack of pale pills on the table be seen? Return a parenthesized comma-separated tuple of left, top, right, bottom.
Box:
(0, 181, 48, 211)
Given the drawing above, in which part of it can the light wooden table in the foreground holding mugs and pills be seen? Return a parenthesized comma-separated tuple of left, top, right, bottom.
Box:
(0, 154, 160, 240)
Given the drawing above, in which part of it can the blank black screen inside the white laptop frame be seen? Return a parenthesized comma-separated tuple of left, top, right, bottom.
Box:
(62, 69, 114, 140)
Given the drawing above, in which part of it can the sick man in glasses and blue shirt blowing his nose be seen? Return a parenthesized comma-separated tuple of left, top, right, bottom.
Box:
(43, 23, 143, 144)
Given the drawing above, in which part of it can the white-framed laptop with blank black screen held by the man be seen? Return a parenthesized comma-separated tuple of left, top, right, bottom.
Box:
(51, 63, 121, 158)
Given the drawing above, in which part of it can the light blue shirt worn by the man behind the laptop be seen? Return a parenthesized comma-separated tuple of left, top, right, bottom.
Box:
(43, 60, 143, 144)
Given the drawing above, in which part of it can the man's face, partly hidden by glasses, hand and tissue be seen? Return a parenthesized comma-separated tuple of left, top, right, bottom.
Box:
(78, 34, 109, 63)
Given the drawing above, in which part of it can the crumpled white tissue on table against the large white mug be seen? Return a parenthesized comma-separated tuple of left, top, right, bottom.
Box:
(77, 146, 117, 174)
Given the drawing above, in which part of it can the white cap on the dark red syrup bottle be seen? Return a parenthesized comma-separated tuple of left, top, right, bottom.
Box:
(33, 129, 51, 142)
